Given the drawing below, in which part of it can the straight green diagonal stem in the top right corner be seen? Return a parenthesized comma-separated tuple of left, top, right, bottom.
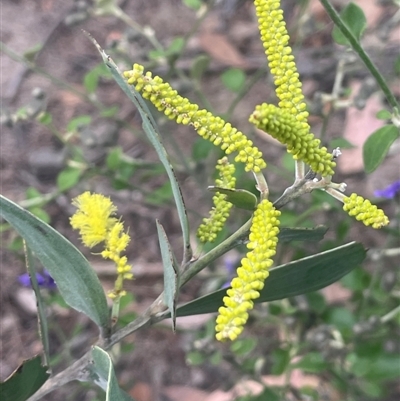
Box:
(320, 0, 400, 112)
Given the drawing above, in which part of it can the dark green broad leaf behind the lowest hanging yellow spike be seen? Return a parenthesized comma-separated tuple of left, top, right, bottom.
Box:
(176, 242, 366, 317)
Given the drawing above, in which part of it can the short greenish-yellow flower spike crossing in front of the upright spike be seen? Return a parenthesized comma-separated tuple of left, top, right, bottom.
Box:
(249, 103, 336, 176)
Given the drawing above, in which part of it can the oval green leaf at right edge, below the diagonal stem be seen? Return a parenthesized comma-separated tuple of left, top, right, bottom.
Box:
(363, 125, 400, 174)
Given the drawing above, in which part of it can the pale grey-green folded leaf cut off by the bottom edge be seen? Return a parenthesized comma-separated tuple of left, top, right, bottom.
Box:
(90, 346, 133, 401)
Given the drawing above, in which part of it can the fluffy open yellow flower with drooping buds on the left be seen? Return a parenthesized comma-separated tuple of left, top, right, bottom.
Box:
(70, 192, 133, 298)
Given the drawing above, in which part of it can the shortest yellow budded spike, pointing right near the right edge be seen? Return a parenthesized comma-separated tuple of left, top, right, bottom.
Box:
(343, 193, 389, 229)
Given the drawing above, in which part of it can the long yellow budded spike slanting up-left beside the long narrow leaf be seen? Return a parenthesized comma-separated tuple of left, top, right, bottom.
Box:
(124, 64, 266, 173)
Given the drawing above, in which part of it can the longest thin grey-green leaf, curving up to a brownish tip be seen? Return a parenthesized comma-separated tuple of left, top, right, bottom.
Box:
(84, 34, 191, 260)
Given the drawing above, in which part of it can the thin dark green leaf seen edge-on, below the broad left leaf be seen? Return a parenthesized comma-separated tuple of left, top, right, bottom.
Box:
(24, 241, 50, 366)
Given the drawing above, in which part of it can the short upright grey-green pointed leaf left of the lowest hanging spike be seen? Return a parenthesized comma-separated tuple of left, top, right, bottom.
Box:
(156, 220, 179, 331)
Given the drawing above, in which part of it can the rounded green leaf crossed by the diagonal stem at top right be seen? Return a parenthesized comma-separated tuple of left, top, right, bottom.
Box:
(332, 2, 367, 45)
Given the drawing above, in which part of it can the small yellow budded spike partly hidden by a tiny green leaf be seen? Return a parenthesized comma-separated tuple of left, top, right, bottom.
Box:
(197, 157, 236, 242)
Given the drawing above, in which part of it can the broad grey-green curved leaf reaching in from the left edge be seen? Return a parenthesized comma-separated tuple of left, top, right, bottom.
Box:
(0, 195, 110, 330)
